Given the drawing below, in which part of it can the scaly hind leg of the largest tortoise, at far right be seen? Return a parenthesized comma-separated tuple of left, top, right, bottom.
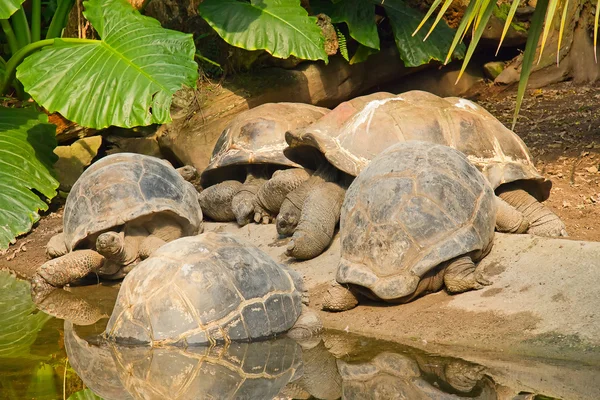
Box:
(498, 185, 568, 237)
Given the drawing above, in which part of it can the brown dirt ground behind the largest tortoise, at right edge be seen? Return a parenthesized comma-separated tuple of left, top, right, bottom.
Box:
(478, 82, 600, 241)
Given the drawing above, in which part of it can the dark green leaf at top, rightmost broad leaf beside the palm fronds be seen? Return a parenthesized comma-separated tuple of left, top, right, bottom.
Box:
(377, 0, 465, 67)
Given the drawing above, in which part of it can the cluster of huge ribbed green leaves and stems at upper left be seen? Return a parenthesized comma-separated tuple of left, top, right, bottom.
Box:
(0, 0, 198, 250)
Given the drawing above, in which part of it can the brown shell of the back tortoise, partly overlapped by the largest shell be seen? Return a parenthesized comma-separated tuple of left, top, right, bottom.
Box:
(202, 103, 329, 187)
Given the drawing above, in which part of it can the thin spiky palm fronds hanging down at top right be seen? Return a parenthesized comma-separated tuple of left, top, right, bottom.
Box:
(419, 0, 588, 129)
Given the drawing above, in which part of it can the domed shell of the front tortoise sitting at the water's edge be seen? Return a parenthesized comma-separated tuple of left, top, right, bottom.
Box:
(106, 232, 302, 346)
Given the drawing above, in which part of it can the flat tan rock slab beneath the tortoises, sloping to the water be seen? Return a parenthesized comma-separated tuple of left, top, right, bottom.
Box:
(206, 223, 600, 365)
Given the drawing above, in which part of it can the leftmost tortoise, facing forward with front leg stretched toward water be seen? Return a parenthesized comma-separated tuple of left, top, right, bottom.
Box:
(32, 153, 202, 295)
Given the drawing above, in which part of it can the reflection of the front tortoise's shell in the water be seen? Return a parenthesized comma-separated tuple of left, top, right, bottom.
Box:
(65, 321, 303, 400)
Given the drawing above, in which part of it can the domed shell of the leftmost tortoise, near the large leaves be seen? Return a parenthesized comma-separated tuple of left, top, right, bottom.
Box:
(63, 153, 202, 251)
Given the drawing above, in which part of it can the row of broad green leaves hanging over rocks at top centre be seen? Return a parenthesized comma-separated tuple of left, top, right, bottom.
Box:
(199, 0, 464, 67)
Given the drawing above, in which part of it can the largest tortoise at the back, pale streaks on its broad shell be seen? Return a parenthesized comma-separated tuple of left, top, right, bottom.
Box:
(284, 91, 566, 258)
